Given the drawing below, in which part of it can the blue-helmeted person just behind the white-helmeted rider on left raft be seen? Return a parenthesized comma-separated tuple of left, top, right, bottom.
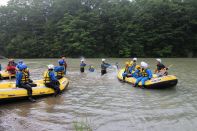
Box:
(54, 59, 65, 79)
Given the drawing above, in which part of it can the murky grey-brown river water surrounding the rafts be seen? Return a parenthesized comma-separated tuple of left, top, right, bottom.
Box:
(0, 58, 197, 131)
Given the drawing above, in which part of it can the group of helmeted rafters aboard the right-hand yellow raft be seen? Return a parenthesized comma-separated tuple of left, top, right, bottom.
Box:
(122, 58, 168, 87)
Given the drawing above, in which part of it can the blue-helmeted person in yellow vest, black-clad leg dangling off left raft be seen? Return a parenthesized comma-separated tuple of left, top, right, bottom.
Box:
(16, 65, 36, 102)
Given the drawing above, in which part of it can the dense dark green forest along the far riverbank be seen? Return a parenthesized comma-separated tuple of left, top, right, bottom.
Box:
(0, 0, 197, 58)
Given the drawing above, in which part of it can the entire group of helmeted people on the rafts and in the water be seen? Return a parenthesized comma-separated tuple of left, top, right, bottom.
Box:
(0, 57, 168, 102)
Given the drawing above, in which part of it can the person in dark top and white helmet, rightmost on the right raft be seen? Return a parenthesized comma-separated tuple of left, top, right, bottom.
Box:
(155, 59, 168, 77)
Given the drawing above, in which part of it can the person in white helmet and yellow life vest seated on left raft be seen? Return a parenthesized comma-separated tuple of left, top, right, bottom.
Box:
(44, 65, 60, 96)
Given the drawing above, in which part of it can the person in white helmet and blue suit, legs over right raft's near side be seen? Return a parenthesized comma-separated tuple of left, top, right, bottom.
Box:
(134, 62, 152, 87)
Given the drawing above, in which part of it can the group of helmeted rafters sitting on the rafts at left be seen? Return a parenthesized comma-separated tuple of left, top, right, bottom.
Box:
(0, 57, 67, 102)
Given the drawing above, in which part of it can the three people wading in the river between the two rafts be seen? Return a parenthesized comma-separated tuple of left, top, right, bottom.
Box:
(80, 58, 111, 75)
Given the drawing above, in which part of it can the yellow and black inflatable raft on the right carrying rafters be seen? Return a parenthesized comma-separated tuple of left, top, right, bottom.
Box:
(117, 69, 178, 89)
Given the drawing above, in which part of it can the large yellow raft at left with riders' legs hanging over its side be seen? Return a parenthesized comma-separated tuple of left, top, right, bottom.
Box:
(0, 77, 69, 102)
